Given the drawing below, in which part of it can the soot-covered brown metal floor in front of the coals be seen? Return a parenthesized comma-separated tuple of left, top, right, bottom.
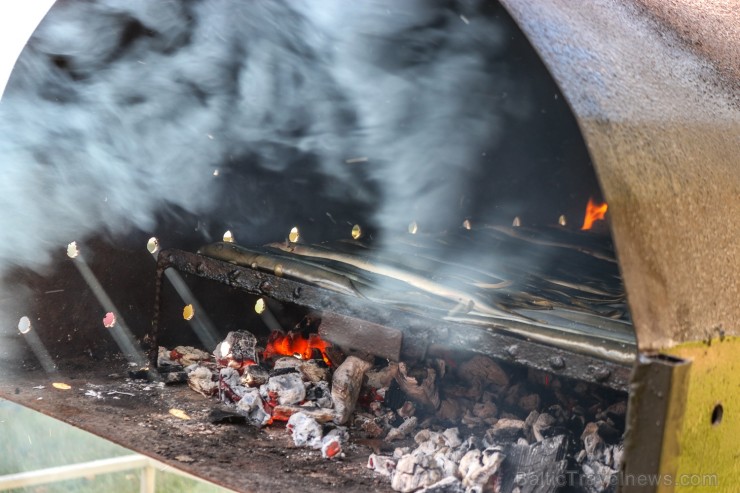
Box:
(0, 358, 393, 493)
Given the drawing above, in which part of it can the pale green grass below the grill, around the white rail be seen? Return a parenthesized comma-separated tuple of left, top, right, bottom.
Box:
(0, 399, 229, 493)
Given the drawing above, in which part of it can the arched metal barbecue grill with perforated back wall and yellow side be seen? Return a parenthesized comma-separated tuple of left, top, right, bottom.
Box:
(0, 0, 740, 491)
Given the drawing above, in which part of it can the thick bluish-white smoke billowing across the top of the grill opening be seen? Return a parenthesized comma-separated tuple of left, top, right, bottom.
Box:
(0, 0, 529, 267)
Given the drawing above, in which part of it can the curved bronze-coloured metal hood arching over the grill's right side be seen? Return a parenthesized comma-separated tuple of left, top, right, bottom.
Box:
(502, 0, 740, 350)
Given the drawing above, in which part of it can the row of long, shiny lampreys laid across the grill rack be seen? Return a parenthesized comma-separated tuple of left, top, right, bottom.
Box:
(199, 228, 634, 362)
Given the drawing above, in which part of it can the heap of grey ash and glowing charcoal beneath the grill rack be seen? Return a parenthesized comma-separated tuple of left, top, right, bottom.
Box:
(158, 322, 627, 493)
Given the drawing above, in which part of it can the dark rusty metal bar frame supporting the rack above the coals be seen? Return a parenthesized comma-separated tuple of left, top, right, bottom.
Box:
(152, 249, 631, 390)
